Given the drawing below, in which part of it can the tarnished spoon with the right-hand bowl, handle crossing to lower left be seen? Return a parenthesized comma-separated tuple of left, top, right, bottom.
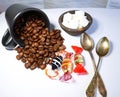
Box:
(86, 37, 110, 97)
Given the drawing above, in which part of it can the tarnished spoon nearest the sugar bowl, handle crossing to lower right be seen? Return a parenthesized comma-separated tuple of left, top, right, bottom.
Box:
(80, 33, 107, 97)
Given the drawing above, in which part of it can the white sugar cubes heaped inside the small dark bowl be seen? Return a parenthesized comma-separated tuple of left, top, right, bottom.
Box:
(62, 11, 89, 29)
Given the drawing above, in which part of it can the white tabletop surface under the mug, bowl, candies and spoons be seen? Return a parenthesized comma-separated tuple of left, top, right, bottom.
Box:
(0, 8, 120, 97)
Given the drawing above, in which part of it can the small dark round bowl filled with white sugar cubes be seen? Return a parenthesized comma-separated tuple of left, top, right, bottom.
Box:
(59, 10, 92, 36)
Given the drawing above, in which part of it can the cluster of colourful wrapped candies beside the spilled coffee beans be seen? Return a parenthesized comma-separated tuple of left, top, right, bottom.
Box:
(45, 46, 88, 82)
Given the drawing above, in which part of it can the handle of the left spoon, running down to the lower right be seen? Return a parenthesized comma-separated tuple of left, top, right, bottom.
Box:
(89, 52, 107, 97)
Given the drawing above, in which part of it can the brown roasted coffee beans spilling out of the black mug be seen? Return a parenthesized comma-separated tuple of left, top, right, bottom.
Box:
(14, 15, 66, 70)
